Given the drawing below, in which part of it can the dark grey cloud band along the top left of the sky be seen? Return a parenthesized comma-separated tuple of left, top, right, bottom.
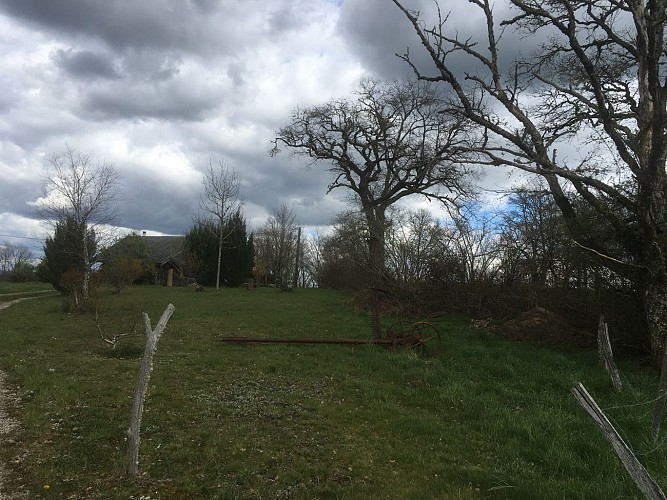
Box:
(0, 0, 312, 59)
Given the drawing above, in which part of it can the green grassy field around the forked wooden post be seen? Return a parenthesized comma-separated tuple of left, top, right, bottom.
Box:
(0, 287, 667, 499)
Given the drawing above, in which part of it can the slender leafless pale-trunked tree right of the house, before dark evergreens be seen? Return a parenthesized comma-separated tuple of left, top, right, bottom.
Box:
(200, 160, 241, 291)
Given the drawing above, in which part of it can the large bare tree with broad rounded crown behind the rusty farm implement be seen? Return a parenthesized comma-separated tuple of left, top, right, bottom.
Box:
(273, 79, 470, 282)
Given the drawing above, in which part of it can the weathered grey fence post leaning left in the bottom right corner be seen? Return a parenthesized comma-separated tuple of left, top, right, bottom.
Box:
(571, 384, 667, 500)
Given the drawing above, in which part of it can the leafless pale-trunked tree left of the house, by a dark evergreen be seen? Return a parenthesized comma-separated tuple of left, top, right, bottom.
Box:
(38, 146, 120, 307)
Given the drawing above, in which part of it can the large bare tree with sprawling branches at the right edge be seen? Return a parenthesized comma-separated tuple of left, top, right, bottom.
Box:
(392, 0, 667, 354)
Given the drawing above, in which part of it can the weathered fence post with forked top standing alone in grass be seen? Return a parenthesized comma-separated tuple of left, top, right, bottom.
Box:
(127, 304, 175, 476)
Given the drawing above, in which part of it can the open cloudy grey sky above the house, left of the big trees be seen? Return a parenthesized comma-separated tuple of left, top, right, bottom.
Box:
(0, 0, 500, 252)
